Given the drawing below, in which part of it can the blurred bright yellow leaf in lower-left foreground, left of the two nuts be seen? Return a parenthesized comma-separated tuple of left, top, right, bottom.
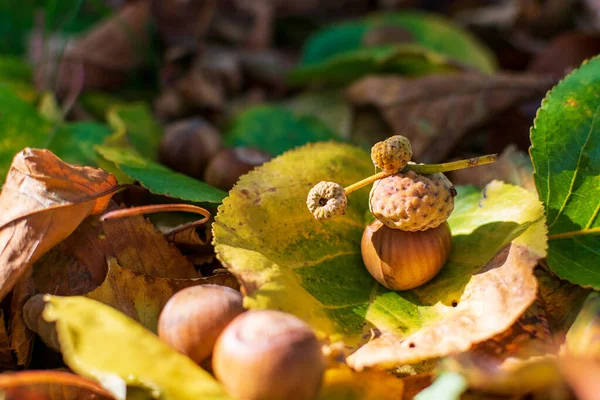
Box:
(42, 296, 228, 400)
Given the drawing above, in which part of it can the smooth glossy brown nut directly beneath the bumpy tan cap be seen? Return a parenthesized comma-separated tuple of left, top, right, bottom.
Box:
(361, 221, 452, 290)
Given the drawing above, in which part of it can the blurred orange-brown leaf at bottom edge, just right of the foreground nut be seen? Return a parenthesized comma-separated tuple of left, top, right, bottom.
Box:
(318, 367, 404, 400)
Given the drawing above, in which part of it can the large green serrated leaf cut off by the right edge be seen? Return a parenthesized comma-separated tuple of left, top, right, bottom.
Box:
(530, 57, 600, 289)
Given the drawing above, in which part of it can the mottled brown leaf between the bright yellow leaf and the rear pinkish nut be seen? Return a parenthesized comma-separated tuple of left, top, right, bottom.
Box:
(86, 258, 239, 333)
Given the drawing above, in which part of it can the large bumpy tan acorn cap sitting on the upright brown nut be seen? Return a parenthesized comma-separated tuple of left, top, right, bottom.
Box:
(369, 171, 456, 232)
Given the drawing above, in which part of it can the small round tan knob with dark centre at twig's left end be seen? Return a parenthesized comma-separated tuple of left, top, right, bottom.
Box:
(306, 181, 348, 219)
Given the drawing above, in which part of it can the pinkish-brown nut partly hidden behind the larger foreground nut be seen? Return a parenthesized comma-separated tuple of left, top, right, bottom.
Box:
(158, 284, 245, 364)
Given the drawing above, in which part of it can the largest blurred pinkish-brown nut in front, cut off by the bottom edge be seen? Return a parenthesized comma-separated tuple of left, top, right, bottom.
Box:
(212, 310, 325, 400)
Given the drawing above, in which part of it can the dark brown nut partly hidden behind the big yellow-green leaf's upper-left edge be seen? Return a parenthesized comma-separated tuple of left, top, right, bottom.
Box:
(204, 147, 271, 191)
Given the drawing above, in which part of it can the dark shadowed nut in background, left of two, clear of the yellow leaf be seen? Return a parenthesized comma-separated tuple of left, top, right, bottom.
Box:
(159, 118, 222, 179)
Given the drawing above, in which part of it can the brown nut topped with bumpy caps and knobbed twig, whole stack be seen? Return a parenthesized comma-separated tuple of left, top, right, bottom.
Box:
(306, 135, 497, 290)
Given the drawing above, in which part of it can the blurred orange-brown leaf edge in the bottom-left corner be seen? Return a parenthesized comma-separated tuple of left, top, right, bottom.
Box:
(0, 371, 115, 400)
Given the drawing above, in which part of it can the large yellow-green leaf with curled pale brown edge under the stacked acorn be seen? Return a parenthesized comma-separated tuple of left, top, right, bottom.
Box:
(213, 143, 546, 369)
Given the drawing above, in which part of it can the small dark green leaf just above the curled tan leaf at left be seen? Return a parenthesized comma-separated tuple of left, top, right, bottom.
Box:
(48, 122, 112, 166)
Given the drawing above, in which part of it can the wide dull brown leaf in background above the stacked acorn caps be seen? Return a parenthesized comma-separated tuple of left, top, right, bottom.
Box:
(347, 73, 553, 162)
